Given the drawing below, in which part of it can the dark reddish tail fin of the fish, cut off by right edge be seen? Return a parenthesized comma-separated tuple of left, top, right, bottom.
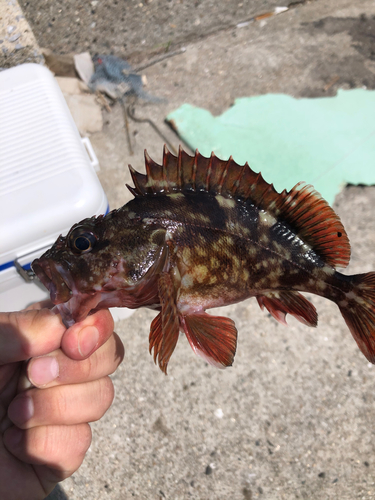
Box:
(338, 272, 375, 364)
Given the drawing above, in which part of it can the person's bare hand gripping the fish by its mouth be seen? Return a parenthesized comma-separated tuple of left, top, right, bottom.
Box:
(0, 304, 124, 500)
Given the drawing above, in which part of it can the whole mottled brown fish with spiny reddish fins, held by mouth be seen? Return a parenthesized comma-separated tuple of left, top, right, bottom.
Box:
(32, 146, 375, 374)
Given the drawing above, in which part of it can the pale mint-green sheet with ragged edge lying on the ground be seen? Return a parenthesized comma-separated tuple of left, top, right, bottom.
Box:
(167, 89, 375, 204)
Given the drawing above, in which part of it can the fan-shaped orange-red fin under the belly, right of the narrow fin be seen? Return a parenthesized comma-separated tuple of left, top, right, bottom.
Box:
(180, 312, 237, 368)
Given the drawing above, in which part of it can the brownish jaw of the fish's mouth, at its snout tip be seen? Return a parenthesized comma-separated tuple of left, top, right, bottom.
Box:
(31, 257, 72, 304)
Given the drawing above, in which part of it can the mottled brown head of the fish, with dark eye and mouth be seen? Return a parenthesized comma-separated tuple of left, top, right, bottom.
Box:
(32, 213, 166, 326)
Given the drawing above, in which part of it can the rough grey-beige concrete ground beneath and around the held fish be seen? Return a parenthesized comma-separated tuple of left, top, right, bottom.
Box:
(3, 0, 375, 500)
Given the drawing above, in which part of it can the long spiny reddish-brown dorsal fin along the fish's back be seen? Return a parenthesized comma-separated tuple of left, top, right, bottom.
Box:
(128, 146, 350, 267)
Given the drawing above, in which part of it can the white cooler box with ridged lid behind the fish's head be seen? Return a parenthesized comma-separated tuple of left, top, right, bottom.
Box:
(0, 64, 108, 311)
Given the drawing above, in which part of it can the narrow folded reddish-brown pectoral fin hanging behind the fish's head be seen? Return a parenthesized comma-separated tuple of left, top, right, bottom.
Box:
(149, 272, 179, 374)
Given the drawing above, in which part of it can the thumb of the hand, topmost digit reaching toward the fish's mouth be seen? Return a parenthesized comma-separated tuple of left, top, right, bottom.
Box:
(0, 309, 66, 365)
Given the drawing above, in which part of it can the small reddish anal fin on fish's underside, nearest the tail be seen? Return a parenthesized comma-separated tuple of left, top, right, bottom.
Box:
(257, 290, 318, 326)
